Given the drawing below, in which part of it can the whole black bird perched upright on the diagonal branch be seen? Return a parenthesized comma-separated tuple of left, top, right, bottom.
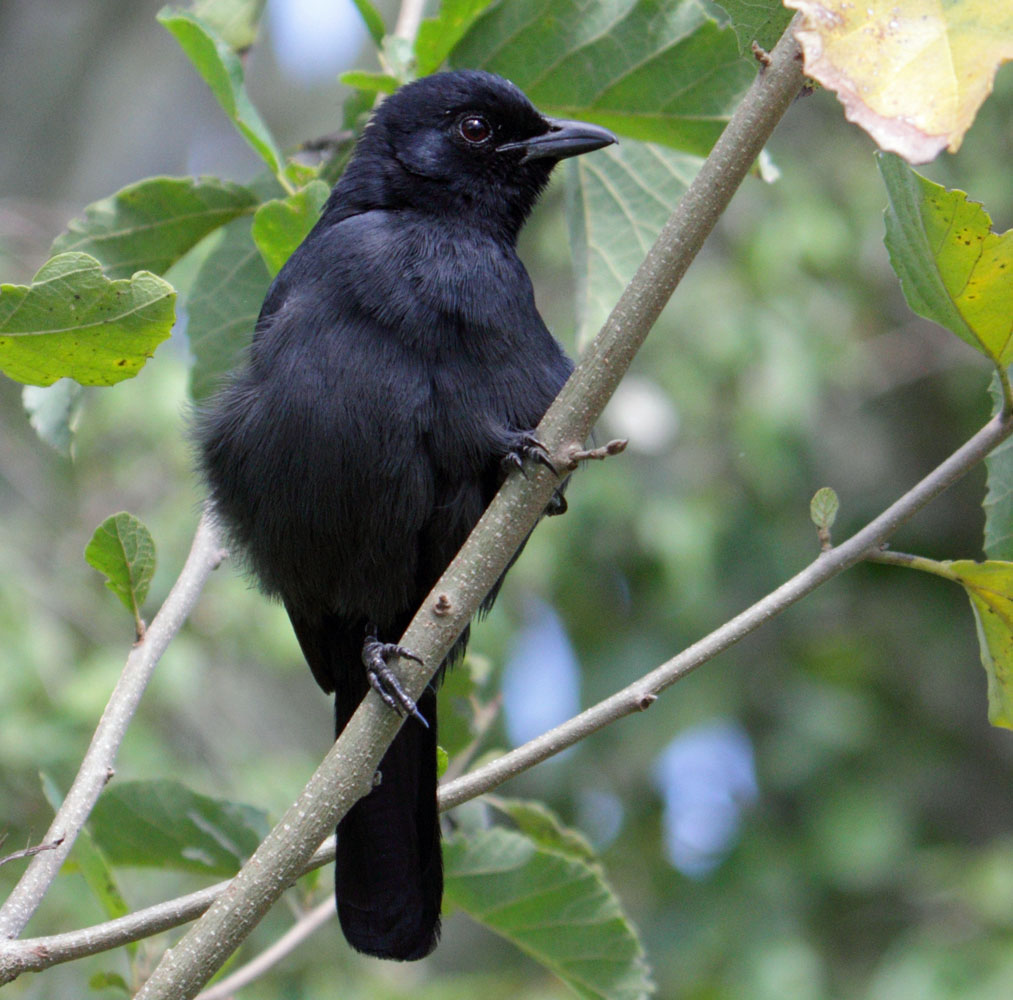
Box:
(196, 71, 616, 959)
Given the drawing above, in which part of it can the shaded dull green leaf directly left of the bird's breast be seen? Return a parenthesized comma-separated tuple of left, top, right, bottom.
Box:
(186, 212, 270, 400)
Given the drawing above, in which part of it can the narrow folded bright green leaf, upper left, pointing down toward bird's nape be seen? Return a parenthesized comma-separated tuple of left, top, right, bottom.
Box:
(158, 7, 283, 173)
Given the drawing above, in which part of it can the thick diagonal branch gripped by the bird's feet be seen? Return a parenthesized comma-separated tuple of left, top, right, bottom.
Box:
(132, 23, 802, 1000)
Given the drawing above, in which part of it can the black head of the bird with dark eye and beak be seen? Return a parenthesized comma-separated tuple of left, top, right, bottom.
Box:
(334, 70, 616, 238)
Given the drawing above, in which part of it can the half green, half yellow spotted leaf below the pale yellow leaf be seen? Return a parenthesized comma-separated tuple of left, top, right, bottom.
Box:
(877, 153, 1013, 368)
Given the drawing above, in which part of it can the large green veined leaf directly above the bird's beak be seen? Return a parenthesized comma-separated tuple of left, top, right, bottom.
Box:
(451, 0, 756, 159)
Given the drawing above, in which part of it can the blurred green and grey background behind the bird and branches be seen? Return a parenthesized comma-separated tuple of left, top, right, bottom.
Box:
(0, 0, 1013, 1000)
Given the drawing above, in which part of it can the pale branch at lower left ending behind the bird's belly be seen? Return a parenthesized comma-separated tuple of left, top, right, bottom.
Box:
(0, 518, 225, 940)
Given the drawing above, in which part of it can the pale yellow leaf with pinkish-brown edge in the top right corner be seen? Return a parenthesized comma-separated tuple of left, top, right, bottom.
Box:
(785, 0, 1013, 163)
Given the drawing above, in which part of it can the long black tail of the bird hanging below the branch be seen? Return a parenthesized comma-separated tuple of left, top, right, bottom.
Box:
(334, 688, 443, 961)
